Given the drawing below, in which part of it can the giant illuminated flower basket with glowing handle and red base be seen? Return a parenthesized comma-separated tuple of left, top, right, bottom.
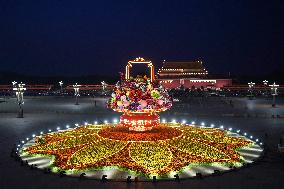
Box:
(108, 58, 172, 131)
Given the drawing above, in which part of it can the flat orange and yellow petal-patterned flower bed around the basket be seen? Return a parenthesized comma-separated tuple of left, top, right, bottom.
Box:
(20, 123, 262, 178)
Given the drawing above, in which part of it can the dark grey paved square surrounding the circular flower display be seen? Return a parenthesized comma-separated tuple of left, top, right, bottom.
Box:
(0, 97, 284, 189)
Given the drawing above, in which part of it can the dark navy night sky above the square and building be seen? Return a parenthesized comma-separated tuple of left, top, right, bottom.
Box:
(0, 0, 284, 75)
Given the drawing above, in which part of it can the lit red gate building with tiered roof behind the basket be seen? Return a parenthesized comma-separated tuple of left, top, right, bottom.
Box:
(158, 61, 232, 88)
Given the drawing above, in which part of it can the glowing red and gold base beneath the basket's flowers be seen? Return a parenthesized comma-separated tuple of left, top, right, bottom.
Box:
(120, 113, 160, 132)
